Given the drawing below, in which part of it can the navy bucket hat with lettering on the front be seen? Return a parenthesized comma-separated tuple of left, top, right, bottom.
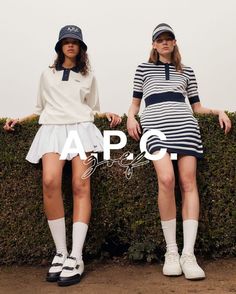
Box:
(55, 25, 87, 53)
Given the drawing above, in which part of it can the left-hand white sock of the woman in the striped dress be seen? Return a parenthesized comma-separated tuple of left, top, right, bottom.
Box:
(161, 218, 178, 253)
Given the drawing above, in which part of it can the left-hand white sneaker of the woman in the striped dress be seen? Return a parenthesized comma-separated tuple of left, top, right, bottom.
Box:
(162, 251, 182, 276)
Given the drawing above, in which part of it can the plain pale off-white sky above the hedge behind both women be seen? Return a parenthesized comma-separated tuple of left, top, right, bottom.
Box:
(0, 0, 236, 117)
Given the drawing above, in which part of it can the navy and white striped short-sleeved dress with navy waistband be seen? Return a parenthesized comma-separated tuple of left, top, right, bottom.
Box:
(133, 61, 203, 158)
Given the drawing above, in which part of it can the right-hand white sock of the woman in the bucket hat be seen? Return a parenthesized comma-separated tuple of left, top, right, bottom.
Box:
(70, 222, 88, 260)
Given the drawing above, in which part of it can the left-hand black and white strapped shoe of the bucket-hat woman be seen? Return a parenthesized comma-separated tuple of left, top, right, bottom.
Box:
(46, 253, 67, 282)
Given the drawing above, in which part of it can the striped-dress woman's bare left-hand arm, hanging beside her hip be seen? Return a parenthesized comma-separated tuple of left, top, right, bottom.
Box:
(127, 98, 142, 141)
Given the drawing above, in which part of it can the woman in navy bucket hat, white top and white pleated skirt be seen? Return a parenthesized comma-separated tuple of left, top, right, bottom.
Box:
(4, 25, 121, 286)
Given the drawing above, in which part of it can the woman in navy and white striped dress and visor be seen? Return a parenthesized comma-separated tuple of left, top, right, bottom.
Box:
(127, 23, 231, 279)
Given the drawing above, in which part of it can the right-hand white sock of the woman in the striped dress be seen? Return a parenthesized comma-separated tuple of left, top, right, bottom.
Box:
(182, 219, 198, 254)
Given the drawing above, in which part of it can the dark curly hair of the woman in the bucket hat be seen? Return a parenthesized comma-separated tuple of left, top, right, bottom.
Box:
(50, 46, 90, 76)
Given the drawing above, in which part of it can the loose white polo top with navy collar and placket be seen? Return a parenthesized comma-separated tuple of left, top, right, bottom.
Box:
(34, 66, 100, 124)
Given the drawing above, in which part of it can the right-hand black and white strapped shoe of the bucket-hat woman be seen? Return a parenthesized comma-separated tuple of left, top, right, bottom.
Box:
(57, 256, 84, 287)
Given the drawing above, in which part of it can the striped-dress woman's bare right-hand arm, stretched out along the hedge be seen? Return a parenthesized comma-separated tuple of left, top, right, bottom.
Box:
(191, 102, 231, 134)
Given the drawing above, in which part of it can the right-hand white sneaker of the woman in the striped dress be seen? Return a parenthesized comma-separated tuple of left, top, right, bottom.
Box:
(180, 253, 206, 280)
